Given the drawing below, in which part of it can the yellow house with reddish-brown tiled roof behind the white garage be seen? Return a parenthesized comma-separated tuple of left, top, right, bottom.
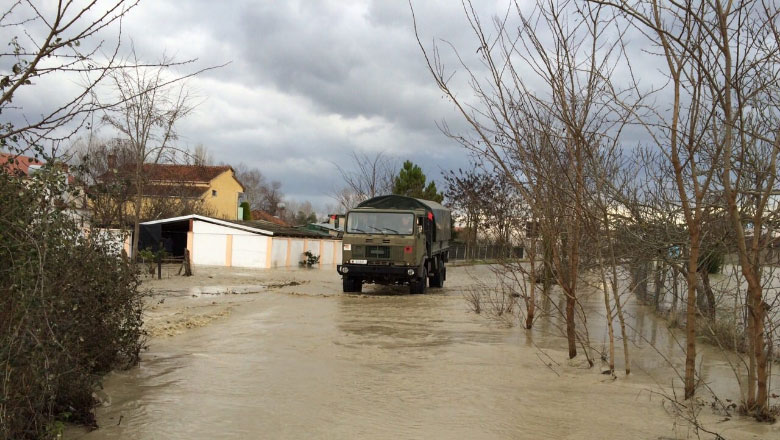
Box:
(101, 164, 244, 220)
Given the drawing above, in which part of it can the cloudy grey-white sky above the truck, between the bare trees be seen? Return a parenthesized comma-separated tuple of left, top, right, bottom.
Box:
(62, 0, 504, 210)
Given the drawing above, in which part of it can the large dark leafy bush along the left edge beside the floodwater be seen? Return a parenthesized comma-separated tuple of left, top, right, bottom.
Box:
(0, 164, 144, 438)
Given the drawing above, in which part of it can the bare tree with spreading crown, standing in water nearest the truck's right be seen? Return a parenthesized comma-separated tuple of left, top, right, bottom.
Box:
(418, 1, 626, 361)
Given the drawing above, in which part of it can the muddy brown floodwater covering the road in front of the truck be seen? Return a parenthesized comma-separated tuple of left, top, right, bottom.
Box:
(68, 267, 780, 439)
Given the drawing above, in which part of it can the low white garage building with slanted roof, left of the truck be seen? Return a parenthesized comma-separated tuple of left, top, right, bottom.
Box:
(139, 215, 341, 269)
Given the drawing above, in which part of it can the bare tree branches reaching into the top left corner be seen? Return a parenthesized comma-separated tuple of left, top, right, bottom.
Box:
(0, 0, 143, 153)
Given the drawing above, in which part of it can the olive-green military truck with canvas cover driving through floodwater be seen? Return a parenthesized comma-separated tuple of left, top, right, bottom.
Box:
(336, 195, 451, 294)
